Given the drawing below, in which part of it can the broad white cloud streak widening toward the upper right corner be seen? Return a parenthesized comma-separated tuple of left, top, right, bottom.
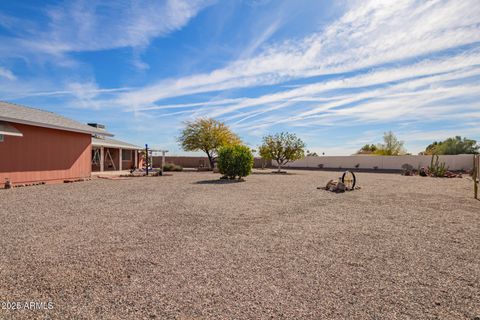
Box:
(109, 0, 480, 106)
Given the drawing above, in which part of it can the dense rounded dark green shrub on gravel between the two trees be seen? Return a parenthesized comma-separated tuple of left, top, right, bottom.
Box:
(217, 145, 253, 179)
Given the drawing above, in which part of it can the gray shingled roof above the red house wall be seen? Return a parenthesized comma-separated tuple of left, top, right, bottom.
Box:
(0, 101, 113, 136)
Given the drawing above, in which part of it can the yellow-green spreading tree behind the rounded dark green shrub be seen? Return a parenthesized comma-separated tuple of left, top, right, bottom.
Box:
(178, 118, 241, 168)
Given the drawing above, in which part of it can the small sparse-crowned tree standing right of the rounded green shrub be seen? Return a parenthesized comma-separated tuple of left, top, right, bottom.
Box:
(259, 132, 305, 172)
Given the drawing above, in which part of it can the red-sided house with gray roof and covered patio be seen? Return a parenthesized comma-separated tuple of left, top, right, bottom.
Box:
(0, 101, 141, 186)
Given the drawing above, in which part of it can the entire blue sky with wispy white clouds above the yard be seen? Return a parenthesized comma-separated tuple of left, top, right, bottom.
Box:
(0, 0, 480, 155)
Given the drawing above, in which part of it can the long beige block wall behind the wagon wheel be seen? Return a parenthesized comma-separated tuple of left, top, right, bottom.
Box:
(280, 154, 473, 170)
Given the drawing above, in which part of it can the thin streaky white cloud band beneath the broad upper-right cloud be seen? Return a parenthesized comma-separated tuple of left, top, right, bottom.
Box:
(143, 51, 480, 123)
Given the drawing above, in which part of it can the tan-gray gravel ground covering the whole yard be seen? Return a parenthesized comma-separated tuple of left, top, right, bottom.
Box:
(0, 170, 480, 319)
